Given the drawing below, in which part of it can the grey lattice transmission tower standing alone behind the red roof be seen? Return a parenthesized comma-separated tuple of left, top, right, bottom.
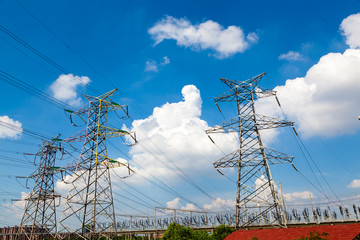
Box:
(206, 73, 293, 228)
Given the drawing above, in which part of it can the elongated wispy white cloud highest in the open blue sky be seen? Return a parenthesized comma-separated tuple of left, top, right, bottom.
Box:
(148, 16, 258, 58)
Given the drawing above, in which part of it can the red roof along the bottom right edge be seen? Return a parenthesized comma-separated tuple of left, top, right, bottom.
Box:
(225, 223, 360, 240)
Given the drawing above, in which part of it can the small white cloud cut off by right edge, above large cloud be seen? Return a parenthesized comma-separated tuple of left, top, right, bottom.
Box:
(340, 13, 360, 48)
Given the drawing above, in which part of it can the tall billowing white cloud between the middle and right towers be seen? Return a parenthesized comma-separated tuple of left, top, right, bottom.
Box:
(124, 85, 237, 181)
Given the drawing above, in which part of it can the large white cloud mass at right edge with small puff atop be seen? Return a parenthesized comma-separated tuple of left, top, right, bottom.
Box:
(257, 14, 360, 137)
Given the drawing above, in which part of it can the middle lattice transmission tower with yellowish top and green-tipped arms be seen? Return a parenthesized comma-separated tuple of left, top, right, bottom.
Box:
(58, 89, 134, 239)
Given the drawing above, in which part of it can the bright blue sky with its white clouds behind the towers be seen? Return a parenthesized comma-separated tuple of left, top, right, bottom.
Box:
(0, 0, 360, 227)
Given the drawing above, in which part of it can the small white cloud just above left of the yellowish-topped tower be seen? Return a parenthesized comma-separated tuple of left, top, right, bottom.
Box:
(50, 74, 90, 106)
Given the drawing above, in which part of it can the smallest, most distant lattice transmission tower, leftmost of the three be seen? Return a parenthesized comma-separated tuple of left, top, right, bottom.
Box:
(17, 137, 63, 240)
